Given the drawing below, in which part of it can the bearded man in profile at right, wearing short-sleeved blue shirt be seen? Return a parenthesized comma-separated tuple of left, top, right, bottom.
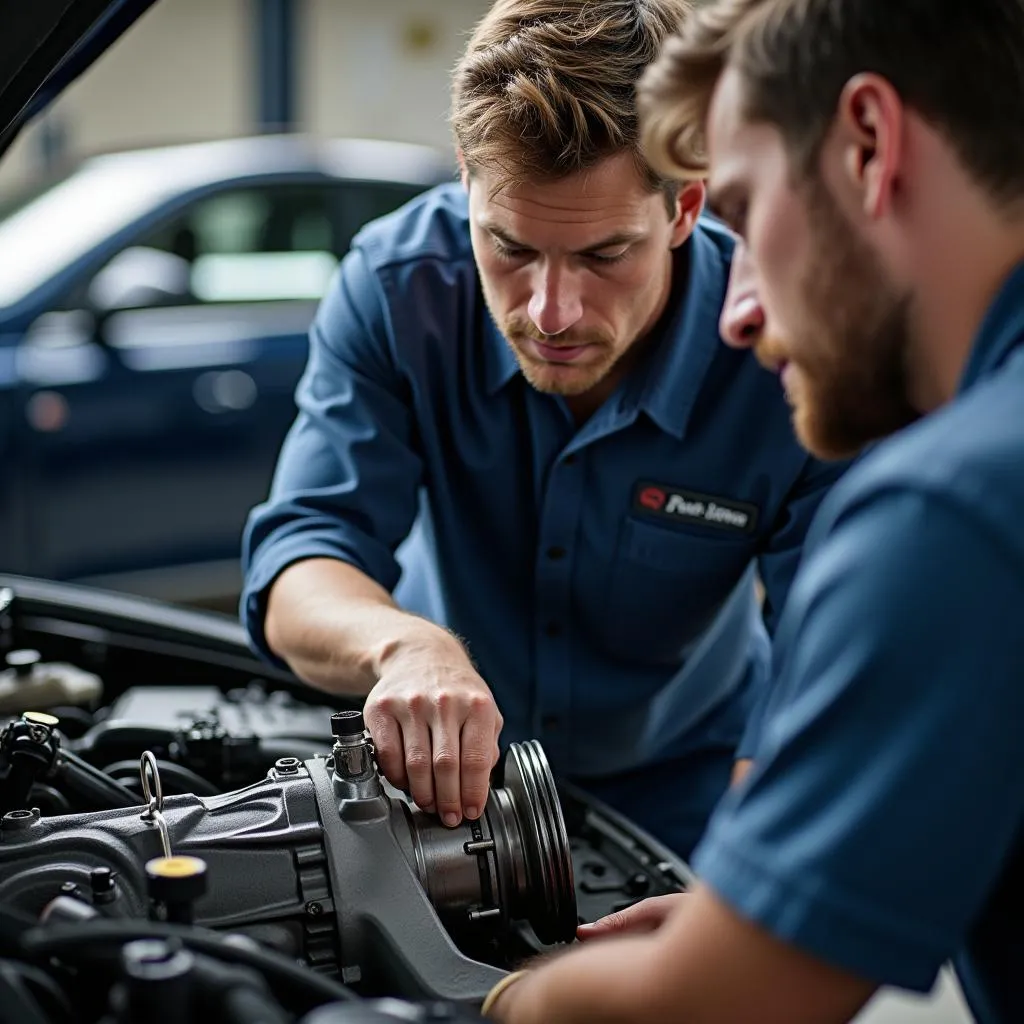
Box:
(486, 0, 1024, 1024)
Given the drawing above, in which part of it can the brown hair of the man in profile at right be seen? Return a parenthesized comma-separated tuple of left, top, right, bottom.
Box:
(639, 0, 1024, 203)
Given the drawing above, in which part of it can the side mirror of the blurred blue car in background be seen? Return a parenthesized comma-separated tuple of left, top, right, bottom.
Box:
(87, 246, 191, 321)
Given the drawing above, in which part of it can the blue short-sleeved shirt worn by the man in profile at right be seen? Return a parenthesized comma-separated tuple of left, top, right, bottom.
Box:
(695, 266, 1024, 1024)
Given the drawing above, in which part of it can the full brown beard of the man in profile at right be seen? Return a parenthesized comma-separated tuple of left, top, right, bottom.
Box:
(759, 183, 920, 459)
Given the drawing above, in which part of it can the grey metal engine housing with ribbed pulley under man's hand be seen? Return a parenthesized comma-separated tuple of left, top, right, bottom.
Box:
(0, 712, 578, 1001)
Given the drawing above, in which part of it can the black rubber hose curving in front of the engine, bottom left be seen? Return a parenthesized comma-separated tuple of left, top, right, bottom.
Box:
(22, 921, 356, 1012)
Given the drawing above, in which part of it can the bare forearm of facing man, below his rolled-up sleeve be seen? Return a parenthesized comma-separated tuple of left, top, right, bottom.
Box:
(265, 558, 468, 695)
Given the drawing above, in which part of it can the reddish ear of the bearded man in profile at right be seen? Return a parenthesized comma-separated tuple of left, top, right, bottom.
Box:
(834, 74, 904, 220)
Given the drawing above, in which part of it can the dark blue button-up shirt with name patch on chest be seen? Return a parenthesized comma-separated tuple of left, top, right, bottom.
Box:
(243, 185, 840, 776)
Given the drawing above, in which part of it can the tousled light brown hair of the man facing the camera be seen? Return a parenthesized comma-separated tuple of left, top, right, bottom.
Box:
(452, 0, 692, 198)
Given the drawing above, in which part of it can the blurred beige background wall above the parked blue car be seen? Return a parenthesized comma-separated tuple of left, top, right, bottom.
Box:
(0, 0, 489, 198)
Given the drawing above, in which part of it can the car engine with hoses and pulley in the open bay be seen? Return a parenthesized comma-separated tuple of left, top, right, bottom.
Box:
(0, 591, 689, 1024)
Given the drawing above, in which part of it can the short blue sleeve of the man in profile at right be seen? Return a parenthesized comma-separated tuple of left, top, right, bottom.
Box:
(694, 490, 1024, 991)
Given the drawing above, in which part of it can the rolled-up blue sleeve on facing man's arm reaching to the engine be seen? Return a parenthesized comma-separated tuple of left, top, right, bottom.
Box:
(241, 248, 422, 662)
